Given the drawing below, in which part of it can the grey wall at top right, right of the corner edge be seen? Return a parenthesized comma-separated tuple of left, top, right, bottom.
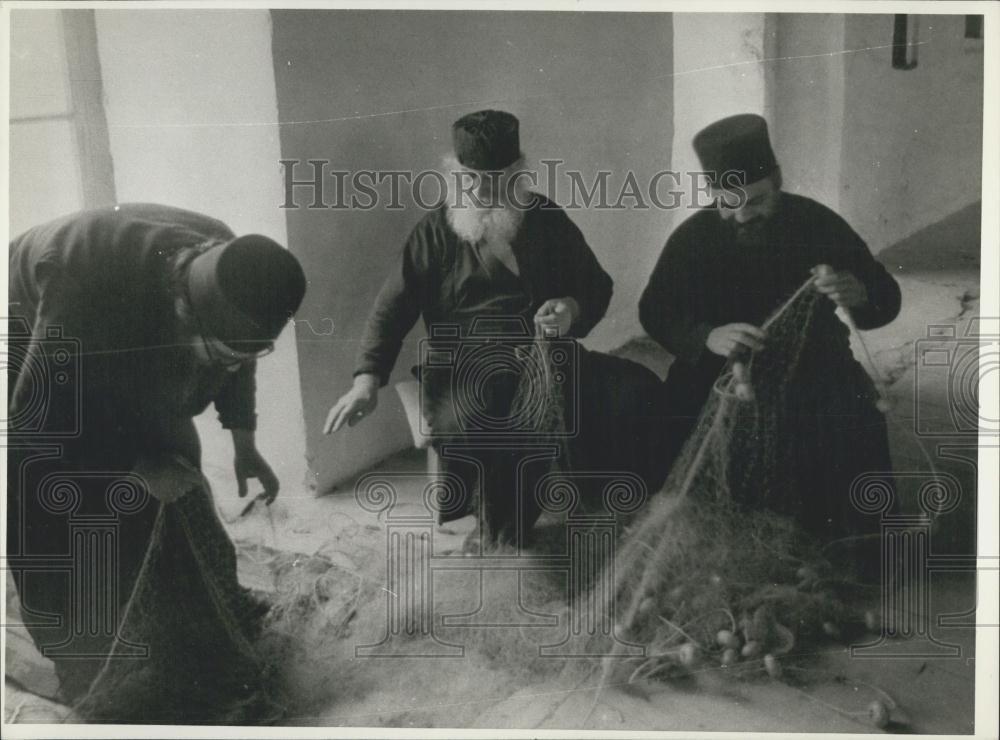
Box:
(840, 15, 980, 252)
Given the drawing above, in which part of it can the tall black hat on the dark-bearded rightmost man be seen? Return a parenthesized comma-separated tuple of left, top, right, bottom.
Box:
(693, 113, 778, 186)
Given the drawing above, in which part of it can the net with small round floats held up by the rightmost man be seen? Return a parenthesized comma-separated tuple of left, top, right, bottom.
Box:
(572, 281, 892, 680)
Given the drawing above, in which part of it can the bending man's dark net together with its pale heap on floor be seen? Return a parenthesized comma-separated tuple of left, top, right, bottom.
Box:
(41, 508, 382, 725)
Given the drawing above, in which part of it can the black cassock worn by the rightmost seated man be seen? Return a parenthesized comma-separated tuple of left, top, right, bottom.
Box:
(639, 193, 900, 539)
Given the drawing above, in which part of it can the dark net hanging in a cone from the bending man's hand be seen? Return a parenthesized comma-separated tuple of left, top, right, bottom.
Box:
(64, 492, 285, 724)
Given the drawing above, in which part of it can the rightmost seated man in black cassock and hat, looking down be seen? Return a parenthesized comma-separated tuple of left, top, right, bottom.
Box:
(639, 115, 900, 540)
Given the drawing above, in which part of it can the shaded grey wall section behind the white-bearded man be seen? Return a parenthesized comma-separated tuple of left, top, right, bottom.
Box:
(272, 10, 673, 488)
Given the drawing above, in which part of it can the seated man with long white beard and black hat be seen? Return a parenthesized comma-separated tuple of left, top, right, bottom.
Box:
(326, 111, 658, 546)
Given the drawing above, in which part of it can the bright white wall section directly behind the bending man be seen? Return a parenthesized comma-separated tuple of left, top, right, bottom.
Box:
(96, 9, 306, 490)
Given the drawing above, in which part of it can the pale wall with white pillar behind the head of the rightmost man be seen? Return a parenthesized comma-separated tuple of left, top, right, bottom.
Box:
(674, 13, 983, 252)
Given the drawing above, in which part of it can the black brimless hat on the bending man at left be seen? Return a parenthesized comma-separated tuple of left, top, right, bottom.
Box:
(187, 234, 306, 352)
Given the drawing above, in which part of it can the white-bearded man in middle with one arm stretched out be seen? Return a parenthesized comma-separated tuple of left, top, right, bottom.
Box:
(325, 110, 640, 546)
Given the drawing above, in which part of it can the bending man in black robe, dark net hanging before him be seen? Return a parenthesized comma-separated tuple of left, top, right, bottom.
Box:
(7, 204, 305, 722)
